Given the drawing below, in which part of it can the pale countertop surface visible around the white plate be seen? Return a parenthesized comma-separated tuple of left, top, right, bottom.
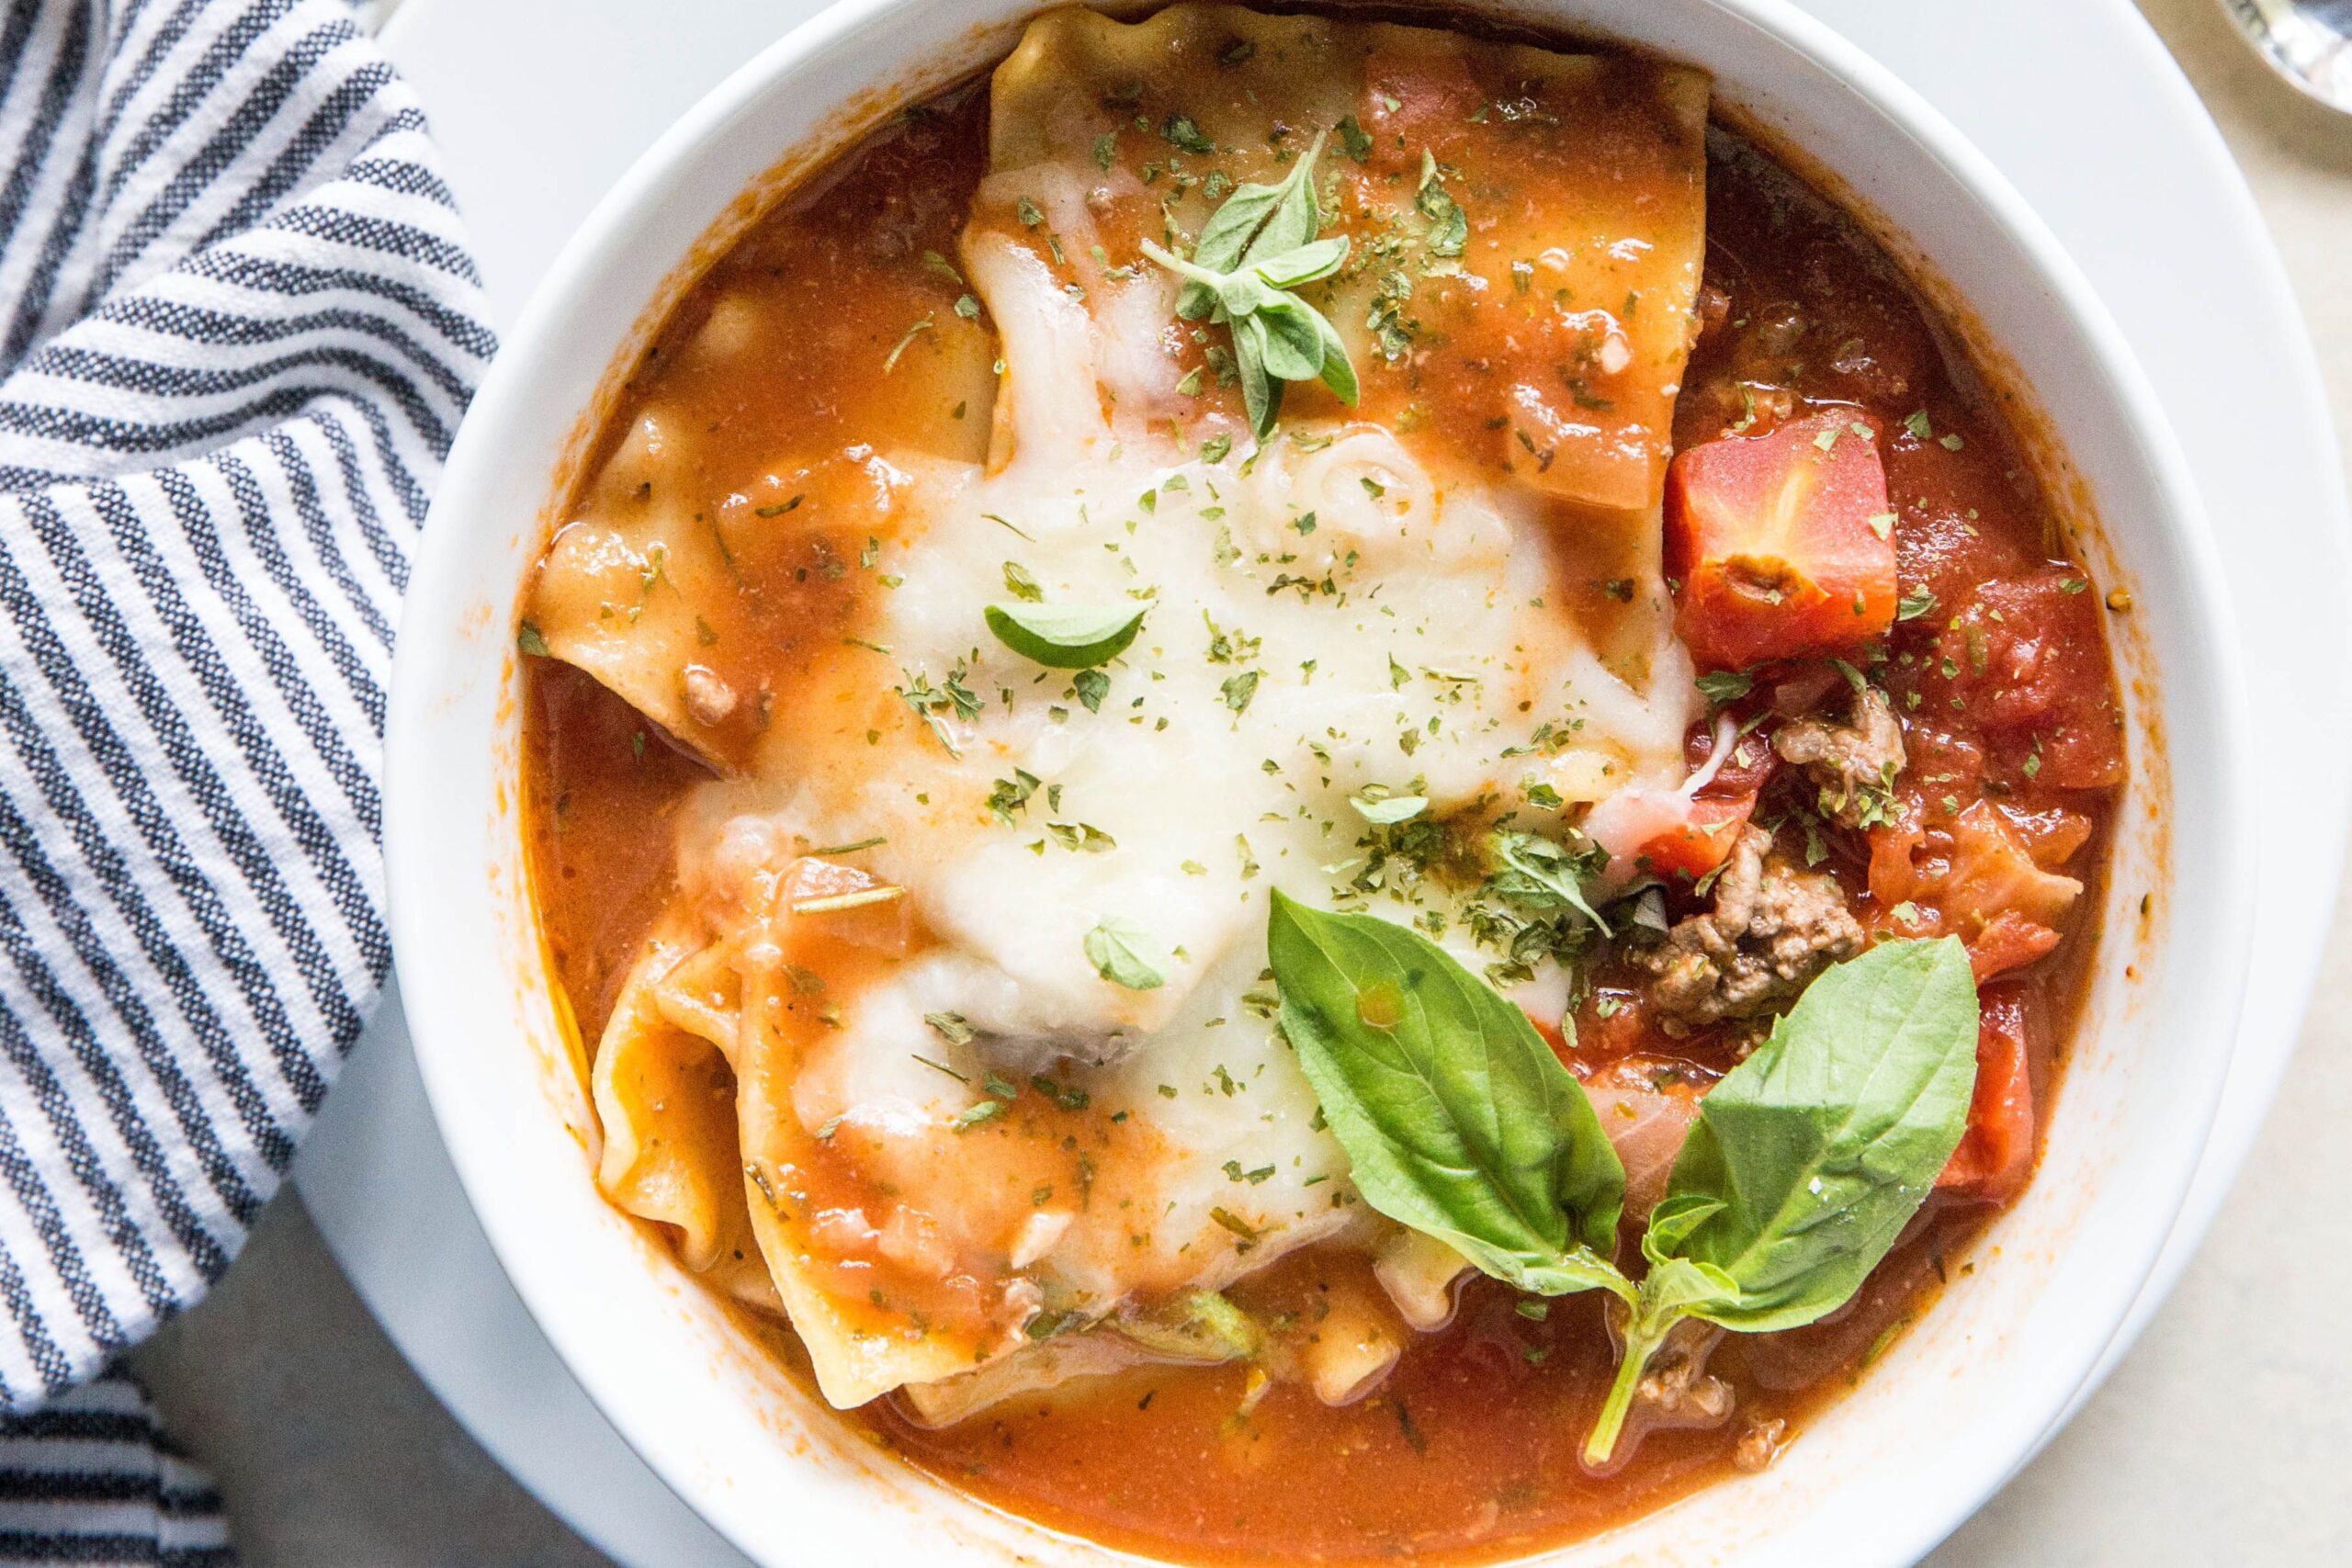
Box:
(131, 0, 2352, 1568)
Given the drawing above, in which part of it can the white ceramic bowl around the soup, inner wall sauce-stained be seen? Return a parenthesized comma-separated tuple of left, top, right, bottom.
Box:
(386, 0, 2253, 1568)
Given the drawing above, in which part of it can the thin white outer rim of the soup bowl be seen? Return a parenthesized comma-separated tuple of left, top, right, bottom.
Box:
(383, 0, 2256, 1563)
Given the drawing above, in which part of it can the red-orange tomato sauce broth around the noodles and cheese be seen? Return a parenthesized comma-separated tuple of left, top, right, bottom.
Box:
(522, 28, 2124, 1563)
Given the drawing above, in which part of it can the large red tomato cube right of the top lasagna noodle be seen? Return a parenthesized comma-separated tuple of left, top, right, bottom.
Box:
(1665, 412, 1895, 670)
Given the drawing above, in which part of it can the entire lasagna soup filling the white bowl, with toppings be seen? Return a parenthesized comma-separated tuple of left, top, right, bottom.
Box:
(517, 5, 2126, 1563)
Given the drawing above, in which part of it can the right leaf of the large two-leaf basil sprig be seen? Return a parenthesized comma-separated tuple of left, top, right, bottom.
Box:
(1665, 936, 1975, 1333)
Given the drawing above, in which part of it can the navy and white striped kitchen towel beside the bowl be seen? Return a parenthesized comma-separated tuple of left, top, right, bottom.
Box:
(0, 0, 492, 1563)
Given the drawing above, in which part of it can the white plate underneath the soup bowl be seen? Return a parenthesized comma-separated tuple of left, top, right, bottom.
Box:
(297, 0, 2352, 1563)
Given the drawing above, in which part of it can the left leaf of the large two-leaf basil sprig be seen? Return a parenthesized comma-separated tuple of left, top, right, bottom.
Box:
(1265, 891, 1633, 1298)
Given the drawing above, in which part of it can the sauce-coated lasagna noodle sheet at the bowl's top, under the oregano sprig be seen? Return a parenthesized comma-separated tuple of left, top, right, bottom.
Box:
(967, 5, 1708, 525)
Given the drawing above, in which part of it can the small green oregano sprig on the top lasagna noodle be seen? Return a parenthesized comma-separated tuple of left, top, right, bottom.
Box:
(1143, 134, 1357, 440)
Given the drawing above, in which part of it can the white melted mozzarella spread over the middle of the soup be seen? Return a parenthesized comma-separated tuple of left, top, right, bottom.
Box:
(644, 223, 1691, 1410)
